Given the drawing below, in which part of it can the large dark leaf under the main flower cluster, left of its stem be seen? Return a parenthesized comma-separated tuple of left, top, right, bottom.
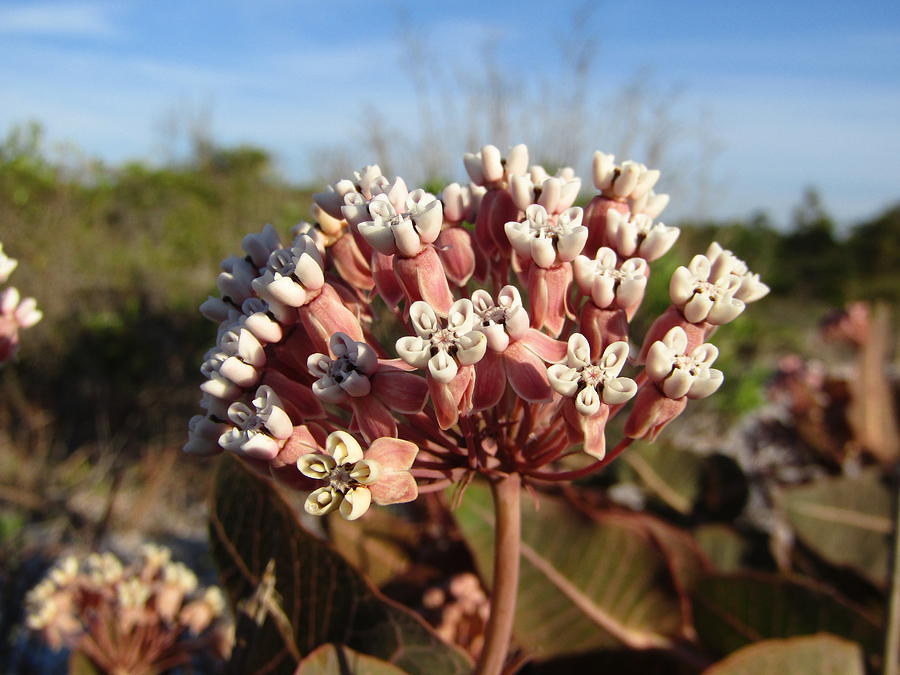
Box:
(210, 457, 471, 675)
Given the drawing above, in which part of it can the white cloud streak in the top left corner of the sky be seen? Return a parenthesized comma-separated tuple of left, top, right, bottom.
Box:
(0, 2, 121, 38)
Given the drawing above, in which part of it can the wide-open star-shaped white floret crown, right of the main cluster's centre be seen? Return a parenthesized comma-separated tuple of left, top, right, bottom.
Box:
(547, 333, 637, 417)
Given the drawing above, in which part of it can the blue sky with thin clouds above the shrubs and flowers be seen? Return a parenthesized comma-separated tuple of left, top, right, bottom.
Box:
(0, 0, 900, 228)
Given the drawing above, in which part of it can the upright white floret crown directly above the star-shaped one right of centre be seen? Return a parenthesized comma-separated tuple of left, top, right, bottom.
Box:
(572, 248, 647, 309)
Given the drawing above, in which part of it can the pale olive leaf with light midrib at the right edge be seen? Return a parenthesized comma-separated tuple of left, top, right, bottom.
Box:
(782, 471, 892, 586)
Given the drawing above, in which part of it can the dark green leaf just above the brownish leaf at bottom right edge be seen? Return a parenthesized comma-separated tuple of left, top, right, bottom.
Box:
(693, 573, 881, 654)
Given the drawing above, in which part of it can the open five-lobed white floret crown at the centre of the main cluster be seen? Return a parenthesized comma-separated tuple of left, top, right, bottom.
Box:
(396, 298, 487, 384)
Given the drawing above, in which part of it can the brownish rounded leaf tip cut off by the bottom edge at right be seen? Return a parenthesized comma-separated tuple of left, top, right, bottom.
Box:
(703, 633, 866, 675)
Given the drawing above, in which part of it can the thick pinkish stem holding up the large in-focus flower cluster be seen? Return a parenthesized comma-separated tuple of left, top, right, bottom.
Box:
(475, 473, 522, 675)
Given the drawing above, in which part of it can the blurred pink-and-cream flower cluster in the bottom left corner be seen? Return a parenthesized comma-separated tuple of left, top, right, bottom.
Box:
(26, 545, 230, 674)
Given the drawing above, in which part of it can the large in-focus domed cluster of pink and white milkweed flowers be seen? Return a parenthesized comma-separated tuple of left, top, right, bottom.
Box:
(185, 145, 768, 519)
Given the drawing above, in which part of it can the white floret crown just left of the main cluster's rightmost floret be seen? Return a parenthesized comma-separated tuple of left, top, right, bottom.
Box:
(669, 255, 745, 325)
